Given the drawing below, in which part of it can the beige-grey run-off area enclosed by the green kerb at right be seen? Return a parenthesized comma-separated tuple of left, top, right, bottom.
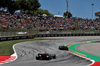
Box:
(75, 43, 100, 57)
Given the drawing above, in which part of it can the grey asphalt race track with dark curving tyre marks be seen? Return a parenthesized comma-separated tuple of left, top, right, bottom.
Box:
(0, 37, 100, 66)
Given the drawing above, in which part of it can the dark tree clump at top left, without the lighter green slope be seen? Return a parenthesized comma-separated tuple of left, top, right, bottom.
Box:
(0, 0, 41, 14)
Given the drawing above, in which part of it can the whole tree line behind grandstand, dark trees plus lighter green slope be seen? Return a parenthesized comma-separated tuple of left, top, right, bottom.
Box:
(0, 0, 52, 15)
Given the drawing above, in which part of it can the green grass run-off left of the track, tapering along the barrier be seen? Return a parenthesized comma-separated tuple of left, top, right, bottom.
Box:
(0, 38, 57, 56)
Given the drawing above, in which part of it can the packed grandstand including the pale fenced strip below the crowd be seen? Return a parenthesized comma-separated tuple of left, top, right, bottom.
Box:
(0, 14, 100, 36)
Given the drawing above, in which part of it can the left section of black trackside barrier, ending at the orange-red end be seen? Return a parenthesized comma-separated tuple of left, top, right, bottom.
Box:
(0, 34, 35, 41)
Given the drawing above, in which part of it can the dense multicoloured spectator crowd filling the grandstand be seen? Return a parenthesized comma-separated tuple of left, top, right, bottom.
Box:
(0, 13, 100, 31)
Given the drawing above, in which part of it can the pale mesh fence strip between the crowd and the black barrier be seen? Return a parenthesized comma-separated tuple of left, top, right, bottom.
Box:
(0, 30, 100, 37)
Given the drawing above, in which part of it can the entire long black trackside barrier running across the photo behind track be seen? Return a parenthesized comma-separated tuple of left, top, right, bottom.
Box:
(0, 33, 100, 41)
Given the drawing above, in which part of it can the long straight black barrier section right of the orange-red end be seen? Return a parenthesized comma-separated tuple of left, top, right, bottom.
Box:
(35, 33, 100, 37)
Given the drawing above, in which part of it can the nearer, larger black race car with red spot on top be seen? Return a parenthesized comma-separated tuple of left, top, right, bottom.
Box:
(36, 52, 56, 60)
